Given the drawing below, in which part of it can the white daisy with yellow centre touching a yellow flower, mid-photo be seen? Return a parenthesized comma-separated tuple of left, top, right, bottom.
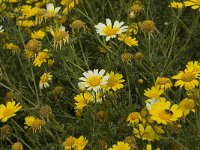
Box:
(79, 69, 109, 92)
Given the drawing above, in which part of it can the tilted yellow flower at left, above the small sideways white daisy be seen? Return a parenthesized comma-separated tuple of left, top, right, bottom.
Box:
(33, 49, 49, 67)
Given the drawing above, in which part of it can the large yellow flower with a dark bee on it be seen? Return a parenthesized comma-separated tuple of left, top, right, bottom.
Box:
(149, 100, 182, 125)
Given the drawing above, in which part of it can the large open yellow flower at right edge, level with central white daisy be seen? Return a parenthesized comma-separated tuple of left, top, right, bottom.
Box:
(172, 69, 199, 90)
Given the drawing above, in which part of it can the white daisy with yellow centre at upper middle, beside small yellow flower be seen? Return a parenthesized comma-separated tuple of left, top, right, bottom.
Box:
(94, 19, 128, 41)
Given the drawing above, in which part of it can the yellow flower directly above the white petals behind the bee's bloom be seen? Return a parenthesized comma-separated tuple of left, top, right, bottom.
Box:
(144, 87, 164, 102)
